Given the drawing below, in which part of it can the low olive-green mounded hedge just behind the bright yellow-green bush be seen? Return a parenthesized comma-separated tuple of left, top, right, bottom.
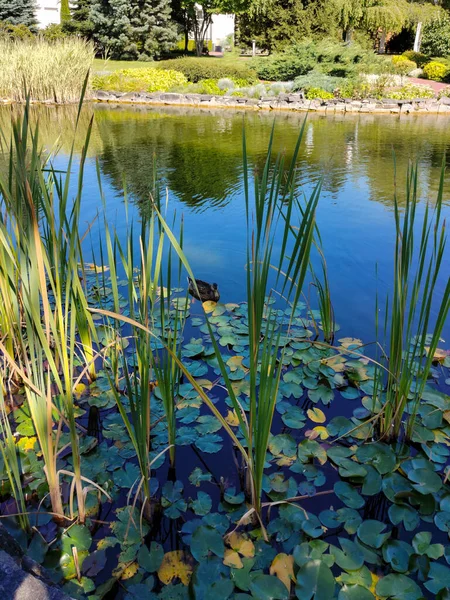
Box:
(157, 57, 256, 83)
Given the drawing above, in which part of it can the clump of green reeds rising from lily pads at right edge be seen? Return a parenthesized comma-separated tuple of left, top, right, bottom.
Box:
(374, 161, 450, 440)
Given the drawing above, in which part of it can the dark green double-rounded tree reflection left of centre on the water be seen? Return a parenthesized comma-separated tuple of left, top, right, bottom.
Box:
(97, 110, 246, 208)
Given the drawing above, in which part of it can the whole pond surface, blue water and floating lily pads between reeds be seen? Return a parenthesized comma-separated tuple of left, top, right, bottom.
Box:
(0, 105, 450, 600)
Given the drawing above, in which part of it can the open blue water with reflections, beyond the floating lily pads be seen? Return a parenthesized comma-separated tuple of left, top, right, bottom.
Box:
(0, 106, 450, 341)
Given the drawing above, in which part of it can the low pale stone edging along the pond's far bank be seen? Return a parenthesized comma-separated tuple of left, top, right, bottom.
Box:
(91, 90, 450, 115)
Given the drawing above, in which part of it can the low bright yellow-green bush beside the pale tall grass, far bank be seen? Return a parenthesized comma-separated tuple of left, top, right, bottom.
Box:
(92, 67, 187, 92)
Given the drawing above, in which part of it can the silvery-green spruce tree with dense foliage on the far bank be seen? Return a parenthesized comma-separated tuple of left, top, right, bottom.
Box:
(90, 0, 177, 60)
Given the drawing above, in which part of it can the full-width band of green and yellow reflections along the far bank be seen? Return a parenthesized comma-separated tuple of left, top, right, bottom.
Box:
(0, 105, 450, 216)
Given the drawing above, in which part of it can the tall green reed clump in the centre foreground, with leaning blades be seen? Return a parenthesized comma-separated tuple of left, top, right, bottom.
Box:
(156, 126, 321, 525)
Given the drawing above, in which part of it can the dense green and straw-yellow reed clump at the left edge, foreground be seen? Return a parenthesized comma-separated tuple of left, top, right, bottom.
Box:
(0, 91, 104, 522)
